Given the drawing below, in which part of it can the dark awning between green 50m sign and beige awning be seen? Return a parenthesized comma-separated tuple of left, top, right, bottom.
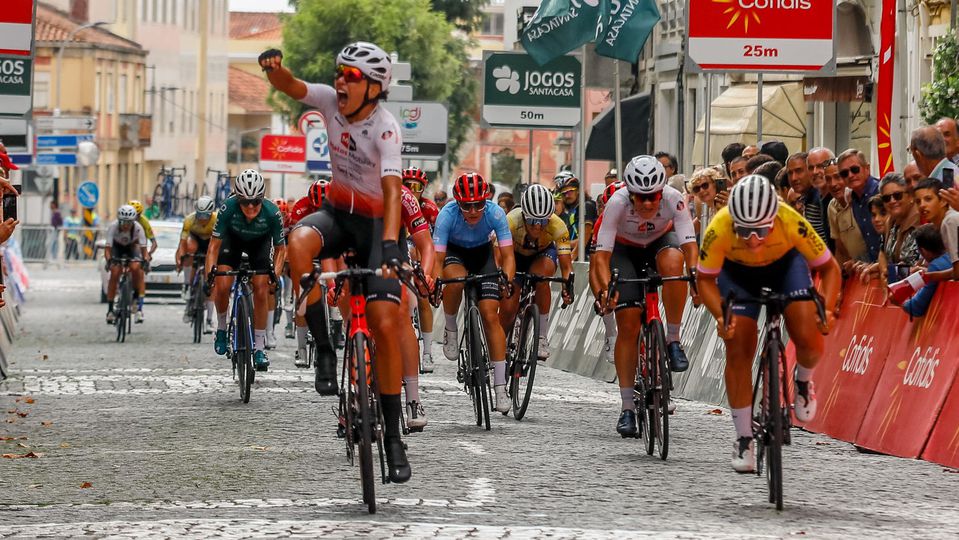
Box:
(586, 93, 650, 161)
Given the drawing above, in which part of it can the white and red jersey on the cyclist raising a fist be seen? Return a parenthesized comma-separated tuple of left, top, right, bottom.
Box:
(300, 83, 403, 218)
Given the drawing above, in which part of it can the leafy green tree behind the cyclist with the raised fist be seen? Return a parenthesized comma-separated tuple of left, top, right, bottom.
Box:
(270, 0, 478, 162)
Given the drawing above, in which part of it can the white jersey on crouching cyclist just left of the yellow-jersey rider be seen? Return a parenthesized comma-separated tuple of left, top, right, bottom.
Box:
(596, 186, 696, 251)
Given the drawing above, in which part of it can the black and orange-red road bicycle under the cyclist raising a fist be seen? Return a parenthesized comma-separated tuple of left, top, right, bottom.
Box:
(296, 254, 424, 514)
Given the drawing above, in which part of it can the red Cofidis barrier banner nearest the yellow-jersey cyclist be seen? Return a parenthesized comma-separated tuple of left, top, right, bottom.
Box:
(787, 280, 907, 442)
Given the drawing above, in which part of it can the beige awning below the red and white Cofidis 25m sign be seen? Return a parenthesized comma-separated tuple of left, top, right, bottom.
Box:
(692, 83, 806, 165)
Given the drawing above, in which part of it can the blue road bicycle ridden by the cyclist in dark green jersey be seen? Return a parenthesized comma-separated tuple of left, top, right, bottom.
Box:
(205, 253, 276, 403)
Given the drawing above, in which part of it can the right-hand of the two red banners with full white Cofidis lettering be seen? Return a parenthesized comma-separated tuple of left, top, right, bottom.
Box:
(856, 284, 959, 458)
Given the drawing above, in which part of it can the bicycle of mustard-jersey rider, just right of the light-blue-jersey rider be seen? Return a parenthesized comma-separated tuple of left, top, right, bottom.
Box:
(503, 272, 574, 420)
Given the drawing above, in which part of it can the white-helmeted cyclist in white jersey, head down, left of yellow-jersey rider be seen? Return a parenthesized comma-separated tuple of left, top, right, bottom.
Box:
(590, 156, 699, 437)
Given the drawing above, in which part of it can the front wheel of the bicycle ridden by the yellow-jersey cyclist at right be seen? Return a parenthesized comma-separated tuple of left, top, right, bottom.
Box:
(763, 337, 783, 510)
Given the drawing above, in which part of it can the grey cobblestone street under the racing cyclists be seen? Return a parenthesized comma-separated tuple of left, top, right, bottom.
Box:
(0, 269, 959, 538)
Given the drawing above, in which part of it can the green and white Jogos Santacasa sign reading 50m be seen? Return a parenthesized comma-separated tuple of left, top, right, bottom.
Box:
(483, 51, 582, 129)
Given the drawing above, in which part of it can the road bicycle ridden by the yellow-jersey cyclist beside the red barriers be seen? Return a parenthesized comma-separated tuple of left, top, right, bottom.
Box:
(723, 287, 826, 510)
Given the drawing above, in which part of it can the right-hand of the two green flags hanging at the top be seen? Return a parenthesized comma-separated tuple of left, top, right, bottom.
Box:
(596, 0, 660, 64)
